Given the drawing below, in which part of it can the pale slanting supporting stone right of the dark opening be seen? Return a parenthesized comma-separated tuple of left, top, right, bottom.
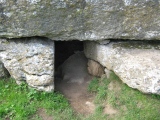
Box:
(84, 41, 160, 94)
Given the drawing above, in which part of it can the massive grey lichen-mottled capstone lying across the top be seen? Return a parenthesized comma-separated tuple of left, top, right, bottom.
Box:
(0, 0, 160, 40)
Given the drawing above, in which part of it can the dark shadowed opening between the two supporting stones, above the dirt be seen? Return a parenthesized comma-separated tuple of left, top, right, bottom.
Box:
(54, 40, 87, 91)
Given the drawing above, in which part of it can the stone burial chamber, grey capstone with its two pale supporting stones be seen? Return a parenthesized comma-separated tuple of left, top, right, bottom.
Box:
(0, 0, 160, 94)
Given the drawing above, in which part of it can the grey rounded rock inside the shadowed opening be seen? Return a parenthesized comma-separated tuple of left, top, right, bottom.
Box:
(59, 52, 90, 84)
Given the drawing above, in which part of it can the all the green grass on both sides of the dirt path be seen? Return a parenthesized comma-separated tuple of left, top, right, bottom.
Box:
(0, 73, 160, 120)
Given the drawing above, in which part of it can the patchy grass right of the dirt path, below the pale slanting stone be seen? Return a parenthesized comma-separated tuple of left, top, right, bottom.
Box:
(89, 72, 160, 120)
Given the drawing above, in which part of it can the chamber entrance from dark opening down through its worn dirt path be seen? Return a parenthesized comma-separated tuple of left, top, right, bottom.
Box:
(55, 40, 95, 114)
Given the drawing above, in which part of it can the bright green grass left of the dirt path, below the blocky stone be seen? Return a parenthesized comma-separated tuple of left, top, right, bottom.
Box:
(0, 79, 77, 120)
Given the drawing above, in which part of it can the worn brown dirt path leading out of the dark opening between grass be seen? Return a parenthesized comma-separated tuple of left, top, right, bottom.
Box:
(55, 77, 95, 115)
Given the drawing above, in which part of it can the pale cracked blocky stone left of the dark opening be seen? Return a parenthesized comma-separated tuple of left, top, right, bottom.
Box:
(0, 38, 54, 92)
